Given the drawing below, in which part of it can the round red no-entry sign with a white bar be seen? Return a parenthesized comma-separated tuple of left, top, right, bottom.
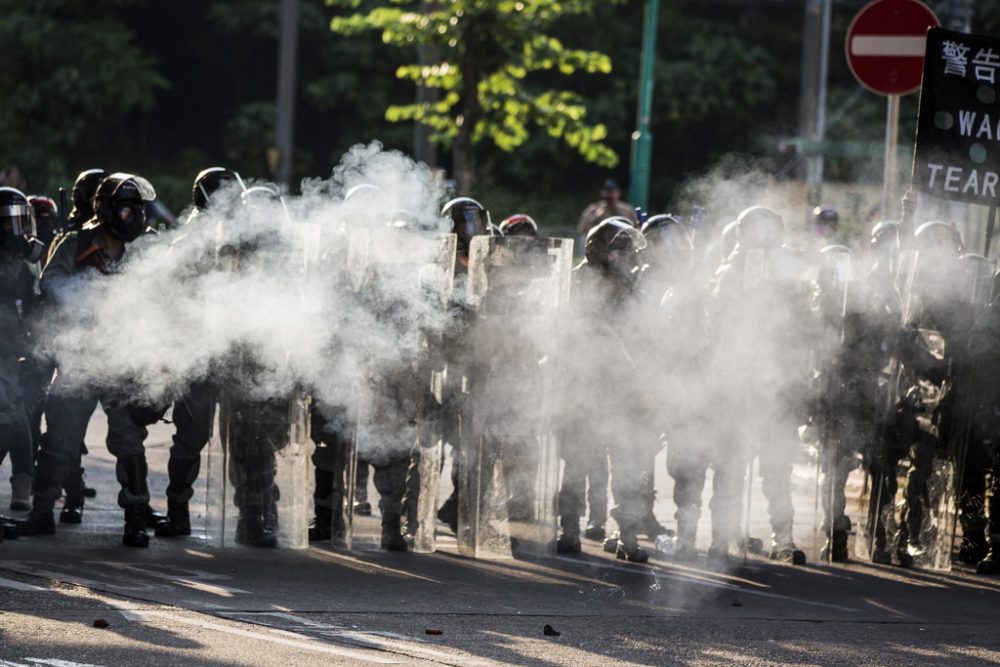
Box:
(845, 0, 940, 95)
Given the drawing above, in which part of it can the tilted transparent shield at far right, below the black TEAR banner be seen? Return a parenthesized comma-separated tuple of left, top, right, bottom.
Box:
(858, 253, 992, 570)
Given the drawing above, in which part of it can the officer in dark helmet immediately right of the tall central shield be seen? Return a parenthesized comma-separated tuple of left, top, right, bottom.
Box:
(557, 218, 650, 563)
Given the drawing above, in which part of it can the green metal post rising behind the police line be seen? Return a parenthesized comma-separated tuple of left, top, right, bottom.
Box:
(629, 0, 660, 209)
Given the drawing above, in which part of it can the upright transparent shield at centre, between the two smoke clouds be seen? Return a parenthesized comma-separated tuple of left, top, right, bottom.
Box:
(458, 236, 573, 558)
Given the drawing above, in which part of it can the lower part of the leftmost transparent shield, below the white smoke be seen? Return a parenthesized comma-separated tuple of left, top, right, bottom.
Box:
(206, 393, 310, 549)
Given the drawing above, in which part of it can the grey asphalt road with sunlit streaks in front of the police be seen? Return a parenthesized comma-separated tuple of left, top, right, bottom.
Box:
(0, 419, 1000, 667)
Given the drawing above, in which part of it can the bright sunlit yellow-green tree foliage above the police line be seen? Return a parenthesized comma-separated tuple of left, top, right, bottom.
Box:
(329, 0, 618, 189)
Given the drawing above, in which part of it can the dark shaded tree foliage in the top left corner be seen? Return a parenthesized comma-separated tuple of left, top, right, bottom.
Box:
(0, 0, 167, 194)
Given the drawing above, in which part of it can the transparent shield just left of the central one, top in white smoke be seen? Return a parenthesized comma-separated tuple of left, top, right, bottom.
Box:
(345, 228, 457, 553)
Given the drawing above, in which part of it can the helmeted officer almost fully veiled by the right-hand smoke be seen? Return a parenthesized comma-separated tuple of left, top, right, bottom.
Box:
(716, 206, 816, 565)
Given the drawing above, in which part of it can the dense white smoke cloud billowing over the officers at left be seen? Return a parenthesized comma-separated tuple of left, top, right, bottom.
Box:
(38, 144, 450, 430)
